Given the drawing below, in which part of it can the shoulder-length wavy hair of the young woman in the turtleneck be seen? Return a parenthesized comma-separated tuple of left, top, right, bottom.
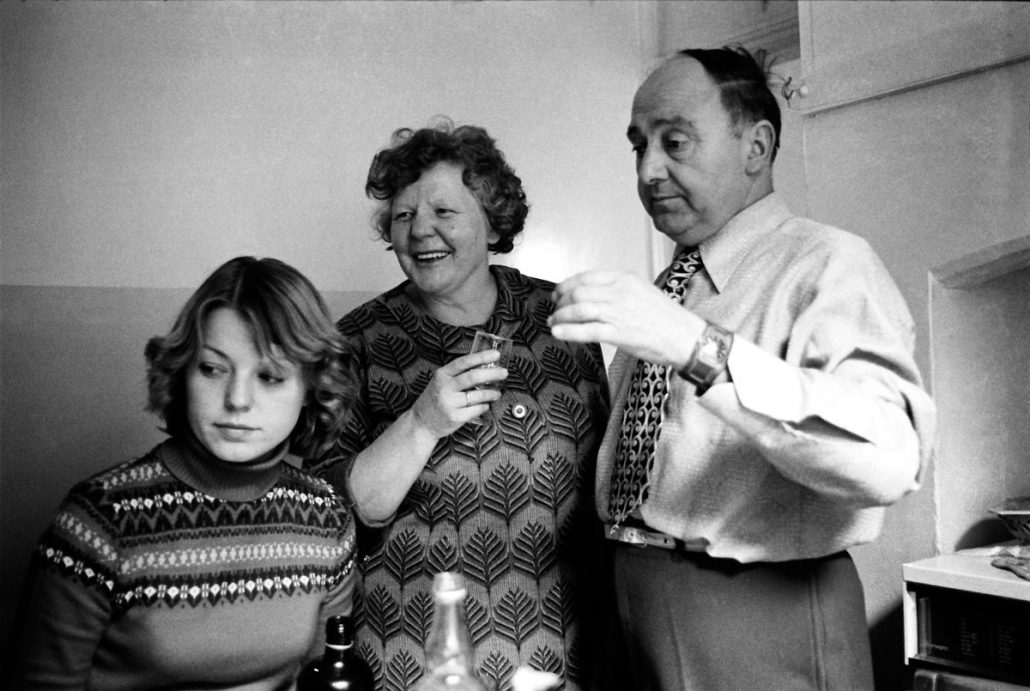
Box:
(144, 256, 355, 457)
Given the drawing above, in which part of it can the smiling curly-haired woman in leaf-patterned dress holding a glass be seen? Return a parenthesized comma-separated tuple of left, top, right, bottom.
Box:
(309, 122, 609, 689)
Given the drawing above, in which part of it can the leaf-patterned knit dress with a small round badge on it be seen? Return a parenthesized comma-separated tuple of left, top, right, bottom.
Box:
(306, 266, 609, 691)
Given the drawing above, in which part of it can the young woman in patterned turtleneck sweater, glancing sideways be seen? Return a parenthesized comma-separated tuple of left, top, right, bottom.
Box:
(7, 256, 356, 690)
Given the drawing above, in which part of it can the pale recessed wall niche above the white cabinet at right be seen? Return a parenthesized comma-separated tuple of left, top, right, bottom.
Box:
(930, 262, 1030, 553)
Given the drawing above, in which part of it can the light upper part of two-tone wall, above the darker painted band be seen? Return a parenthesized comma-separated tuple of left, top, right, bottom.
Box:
(0, 2, 644, 291)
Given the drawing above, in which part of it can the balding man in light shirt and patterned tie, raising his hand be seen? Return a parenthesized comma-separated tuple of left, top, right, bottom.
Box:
(550, 48, 935, 691)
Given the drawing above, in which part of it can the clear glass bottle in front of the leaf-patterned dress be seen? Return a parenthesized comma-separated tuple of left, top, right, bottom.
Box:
(413, 572, 489, 691)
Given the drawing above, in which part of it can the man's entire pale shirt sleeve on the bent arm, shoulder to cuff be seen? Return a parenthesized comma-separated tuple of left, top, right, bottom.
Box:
(701, 240, 935, 506)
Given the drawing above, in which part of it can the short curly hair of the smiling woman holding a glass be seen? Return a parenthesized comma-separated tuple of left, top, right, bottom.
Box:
(365, 119, 529, 253)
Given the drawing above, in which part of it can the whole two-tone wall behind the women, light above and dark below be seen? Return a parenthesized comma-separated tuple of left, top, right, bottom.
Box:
(0, 1, 653, 649)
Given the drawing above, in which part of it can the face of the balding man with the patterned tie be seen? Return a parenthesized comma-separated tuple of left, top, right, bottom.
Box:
(626, 57, 751, 245)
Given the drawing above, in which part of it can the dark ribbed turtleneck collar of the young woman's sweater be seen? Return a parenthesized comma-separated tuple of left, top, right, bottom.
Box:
(160, 435, 289, 502)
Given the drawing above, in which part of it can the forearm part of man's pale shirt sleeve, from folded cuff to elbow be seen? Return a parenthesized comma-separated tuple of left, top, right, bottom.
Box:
(700, 339, 933, 506)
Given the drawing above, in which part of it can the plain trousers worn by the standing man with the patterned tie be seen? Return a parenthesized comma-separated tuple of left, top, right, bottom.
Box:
(609, 543, 873, 691)
